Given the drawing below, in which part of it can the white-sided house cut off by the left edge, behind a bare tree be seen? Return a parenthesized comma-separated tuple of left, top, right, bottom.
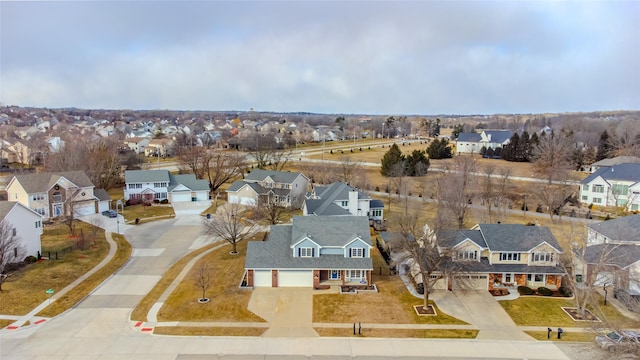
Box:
(0, 201, 43, 260)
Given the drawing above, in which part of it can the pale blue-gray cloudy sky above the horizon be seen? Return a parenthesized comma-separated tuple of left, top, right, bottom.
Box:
(0, 1, 640, 115)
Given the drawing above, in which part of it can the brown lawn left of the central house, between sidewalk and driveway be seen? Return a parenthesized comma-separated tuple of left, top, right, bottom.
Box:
(158, 234, 264, 322)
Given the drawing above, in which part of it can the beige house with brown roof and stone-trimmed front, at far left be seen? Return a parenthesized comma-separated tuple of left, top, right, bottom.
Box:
(7, 171, 109, 219)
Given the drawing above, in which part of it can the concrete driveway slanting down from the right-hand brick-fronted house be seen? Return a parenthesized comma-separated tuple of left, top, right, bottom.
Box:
(431, 290, 533, 340)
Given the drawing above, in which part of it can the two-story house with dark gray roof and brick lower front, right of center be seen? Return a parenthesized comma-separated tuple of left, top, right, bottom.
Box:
(435, 224, 564, 290)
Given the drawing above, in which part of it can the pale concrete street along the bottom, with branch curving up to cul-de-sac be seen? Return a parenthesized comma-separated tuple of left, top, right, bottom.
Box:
(0, 204, 568, 360)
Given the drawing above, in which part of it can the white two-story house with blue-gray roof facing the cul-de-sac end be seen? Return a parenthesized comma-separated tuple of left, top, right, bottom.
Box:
(124, 170, 209, 203)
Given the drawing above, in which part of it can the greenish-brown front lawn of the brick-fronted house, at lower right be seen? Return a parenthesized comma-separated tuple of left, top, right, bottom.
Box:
(498, 297, 640, 330)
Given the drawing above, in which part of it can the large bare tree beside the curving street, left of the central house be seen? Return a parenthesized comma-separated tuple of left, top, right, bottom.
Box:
(203, 203, 259, 254)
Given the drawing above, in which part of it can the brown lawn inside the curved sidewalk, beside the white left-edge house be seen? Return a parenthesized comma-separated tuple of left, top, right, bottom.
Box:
(0, 222, 109, 315)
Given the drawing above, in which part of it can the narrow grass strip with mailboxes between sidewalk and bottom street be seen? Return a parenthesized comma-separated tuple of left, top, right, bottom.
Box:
(314, 325, 478, 339)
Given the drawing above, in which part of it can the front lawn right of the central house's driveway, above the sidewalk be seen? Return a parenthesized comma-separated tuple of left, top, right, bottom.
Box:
(313, 248, 467, 325)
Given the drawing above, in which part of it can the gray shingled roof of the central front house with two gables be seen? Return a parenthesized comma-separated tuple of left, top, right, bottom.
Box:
(245, 216, 373, 270)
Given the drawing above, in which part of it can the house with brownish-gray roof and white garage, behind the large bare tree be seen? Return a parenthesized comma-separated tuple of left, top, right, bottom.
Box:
(227, 169, 310, 209)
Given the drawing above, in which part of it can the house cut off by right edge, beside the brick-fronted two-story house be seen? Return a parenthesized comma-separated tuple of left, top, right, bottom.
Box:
(575, 215, 640, 296)
